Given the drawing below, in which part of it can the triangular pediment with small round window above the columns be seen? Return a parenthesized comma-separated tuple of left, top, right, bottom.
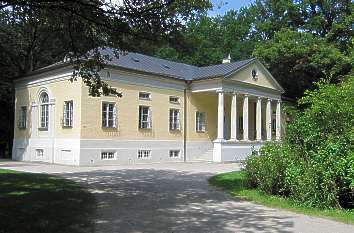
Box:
(225, 60, 284, 93)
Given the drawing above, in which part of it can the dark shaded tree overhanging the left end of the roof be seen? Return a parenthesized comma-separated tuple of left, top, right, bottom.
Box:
(0, 0, 210, 157)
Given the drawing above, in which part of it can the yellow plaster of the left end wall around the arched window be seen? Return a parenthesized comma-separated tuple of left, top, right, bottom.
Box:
(14, 77, 81, 138)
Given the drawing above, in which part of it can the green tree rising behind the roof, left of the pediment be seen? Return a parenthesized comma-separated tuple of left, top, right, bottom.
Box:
(156, 9, 255, 66)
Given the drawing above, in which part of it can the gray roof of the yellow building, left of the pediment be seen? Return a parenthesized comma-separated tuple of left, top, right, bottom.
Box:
(100, 48, 254, 80)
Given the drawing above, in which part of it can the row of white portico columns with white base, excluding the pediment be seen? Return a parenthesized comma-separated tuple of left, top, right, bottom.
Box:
(213, 91, 281, 162)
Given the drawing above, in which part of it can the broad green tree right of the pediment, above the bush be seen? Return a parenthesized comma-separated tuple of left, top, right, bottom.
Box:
(253, 29, 352, 98)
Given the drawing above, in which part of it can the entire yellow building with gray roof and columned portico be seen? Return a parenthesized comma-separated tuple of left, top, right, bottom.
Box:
(13, 49, 284, 165)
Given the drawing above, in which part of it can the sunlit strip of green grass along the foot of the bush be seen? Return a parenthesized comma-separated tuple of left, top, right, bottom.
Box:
(209, 171, 354, 224)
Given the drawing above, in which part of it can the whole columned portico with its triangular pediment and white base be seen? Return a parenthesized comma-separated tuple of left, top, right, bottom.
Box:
(191, 60, 283, 162)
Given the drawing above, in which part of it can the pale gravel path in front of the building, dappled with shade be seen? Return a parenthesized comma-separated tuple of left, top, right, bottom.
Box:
(0, 160, 354, 233)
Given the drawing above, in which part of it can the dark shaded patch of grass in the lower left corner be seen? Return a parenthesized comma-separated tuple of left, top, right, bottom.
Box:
(0, 169, 96, 233)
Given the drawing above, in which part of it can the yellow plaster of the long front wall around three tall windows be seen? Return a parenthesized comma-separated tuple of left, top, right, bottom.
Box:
(81, 79, 184, 140)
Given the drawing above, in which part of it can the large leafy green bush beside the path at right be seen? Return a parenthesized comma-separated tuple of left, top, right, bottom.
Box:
(246, 77, 354, 208)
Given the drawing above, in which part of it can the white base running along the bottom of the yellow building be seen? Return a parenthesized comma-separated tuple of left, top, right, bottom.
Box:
(13, 138, 261, 166)
